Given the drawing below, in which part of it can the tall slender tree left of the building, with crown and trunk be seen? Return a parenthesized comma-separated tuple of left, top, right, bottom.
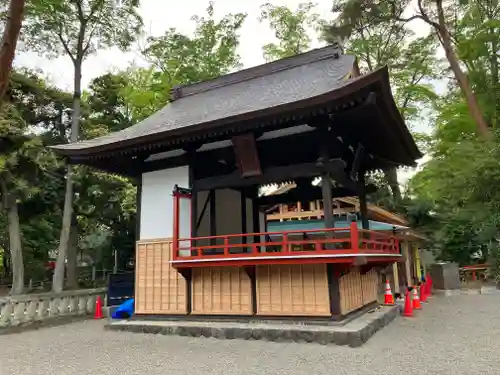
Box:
(24, 0, 142, 292)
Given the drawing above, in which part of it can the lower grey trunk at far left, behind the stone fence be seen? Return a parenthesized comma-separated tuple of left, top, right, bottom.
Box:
(0, 177, 24, 295)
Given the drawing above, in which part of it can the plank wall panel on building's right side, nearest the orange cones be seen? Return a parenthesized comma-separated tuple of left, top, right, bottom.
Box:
(339, 268, 379, 315)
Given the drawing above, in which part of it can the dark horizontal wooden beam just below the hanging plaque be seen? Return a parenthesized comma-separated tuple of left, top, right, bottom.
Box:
(195, 159, 348, 191)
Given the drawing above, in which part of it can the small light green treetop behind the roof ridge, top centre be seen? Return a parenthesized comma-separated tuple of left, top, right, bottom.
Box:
(259, 2, 319, 61)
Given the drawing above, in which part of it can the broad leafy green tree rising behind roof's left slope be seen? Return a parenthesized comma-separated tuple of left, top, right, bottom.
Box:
(122, 2, 246, 121)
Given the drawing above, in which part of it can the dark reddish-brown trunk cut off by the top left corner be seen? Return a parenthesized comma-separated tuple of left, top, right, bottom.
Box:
(0, 0, 25, 103)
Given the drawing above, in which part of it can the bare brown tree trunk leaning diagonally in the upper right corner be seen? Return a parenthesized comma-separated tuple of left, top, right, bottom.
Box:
(435, 1, 493, 139)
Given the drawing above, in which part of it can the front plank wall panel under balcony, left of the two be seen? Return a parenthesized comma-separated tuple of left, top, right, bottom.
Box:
(192, 267, 253, 315)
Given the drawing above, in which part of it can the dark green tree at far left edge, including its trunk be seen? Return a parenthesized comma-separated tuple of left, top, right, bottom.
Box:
(0, 72, 67, 294)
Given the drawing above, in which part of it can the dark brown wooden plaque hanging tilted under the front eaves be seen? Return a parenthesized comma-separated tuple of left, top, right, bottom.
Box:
(232, 133, 262, 178)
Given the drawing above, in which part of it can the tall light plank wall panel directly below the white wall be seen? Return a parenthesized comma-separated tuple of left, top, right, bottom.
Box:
(135, 239, 187, 315)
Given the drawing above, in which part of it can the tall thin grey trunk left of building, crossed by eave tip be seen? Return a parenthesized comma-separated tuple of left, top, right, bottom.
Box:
(52, 58, 83, 292)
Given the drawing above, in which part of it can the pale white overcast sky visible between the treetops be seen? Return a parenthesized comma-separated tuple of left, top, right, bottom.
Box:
(15, 0, 436, 183)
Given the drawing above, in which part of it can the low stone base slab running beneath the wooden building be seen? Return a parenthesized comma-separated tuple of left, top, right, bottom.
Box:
(106, 306, 399, 347)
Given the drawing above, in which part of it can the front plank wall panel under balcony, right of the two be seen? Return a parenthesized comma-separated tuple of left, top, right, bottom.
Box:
(256, 264, 330, 316)
